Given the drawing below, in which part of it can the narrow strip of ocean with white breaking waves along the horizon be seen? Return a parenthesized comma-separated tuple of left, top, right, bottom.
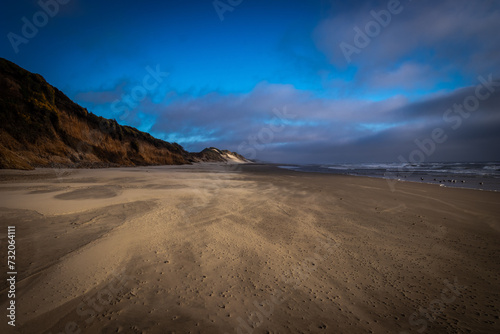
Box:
(278, 162, 500, 191)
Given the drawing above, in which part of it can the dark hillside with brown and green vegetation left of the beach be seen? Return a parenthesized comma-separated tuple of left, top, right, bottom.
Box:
(0, 58, 249, 169)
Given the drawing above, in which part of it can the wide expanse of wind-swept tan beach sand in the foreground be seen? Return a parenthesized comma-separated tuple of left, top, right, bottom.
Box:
(0, 164, 500, 334)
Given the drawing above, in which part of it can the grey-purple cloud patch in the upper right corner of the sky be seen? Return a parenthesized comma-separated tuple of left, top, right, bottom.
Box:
(315, 0, 500, 87)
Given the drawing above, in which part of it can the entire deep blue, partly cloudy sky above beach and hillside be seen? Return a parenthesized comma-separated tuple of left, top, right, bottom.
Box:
(0, 0, 500, 164)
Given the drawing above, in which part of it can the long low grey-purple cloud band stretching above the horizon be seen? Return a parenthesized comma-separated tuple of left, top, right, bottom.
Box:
(138, 77, 500, 163)
